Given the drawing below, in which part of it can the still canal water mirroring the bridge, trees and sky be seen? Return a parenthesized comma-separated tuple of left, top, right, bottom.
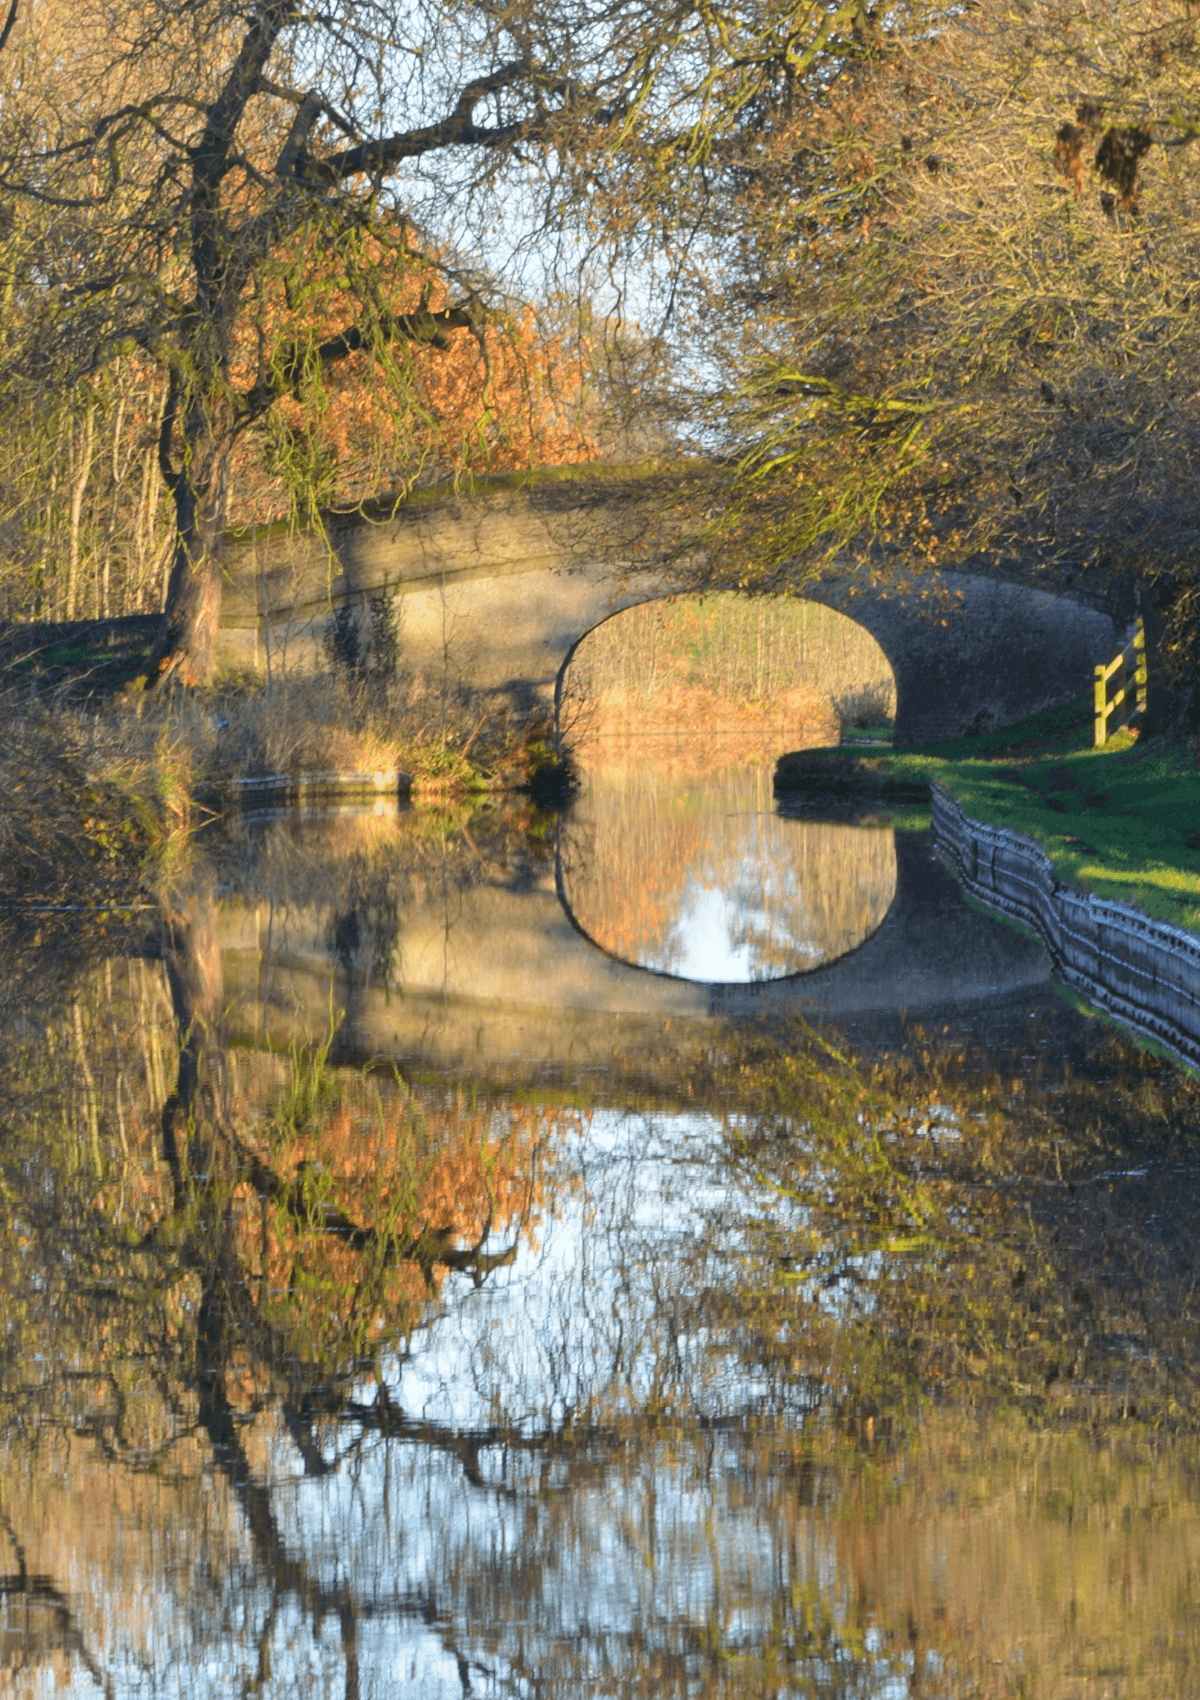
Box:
(0, 753, 1200, 1700)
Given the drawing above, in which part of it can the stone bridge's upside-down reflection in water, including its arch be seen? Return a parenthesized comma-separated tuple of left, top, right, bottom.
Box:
(216, 770, 1049, 1074)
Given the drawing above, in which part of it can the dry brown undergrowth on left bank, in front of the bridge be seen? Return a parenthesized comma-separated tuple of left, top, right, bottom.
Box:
(0, 675, 559, 927)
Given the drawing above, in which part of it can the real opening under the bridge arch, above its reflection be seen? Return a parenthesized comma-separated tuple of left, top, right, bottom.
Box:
(556, 592, 896, 760)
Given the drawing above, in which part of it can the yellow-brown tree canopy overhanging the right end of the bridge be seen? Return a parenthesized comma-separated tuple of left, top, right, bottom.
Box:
(704, 0, 1200, 710)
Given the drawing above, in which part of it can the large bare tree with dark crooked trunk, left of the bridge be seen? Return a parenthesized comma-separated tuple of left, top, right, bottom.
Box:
(0, 0, 890, 680)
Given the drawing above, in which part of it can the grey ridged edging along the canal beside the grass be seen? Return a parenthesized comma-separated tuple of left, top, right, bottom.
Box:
(930, 780, 1200, 1069)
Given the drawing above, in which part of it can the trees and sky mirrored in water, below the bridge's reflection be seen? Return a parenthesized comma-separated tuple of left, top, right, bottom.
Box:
(0, 816, 1200, 1697)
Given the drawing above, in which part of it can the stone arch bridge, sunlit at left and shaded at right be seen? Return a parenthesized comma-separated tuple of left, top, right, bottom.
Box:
(219, 468, 1134, 746)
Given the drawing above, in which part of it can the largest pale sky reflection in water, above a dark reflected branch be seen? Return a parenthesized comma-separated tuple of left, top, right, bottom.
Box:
(396, 1110, 785, 1435)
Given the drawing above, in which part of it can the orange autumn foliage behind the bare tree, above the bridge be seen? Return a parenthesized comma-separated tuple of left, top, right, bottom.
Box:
(231, 235, 600, 525)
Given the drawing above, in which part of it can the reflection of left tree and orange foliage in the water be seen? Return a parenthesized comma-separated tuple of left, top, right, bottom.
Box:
(3, 898, 575, 1693)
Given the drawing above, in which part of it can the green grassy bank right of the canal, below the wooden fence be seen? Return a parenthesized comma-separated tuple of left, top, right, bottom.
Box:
(778, 702, 1200, 932)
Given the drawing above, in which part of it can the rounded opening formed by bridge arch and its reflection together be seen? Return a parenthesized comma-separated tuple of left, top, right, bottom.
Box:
(558, 593, 897, 984)
